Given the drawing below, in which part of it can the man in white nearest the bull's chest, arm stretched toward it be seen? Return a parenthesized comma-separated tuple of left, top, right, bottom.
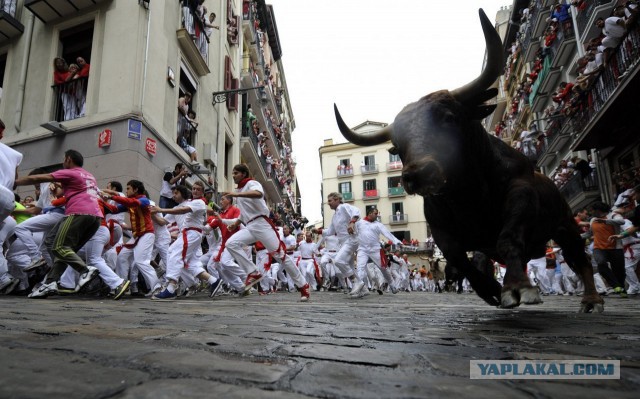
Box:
(351, 208, 402, 298)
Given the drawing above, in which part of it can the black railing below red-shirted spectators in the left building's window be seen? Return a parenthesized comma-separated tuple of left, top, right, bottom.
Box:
(51, 77, 89, 122)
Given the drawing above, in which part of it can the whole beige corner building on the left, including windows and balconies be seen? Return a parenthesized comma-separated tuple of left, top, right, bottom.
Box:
(0, 0, 295, 216)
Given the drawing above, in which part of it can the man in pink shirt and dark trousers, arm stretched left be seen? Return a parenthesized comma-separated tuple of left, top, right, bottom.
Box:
(15, 150, 104, 298)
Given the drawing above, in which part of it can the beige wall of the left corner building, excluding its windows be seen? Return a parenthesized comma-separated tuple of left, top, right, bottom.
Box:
(0, 0, 242, 200)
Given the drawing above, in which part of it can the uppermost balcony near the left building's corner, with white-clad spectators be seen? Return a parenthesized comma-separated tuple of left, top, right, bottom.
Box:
(176, 7, 211, 76)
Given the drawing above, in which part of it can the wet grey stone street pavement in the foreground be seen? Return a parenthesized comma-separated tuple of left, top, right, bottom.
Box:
(0, 292, 640, 399)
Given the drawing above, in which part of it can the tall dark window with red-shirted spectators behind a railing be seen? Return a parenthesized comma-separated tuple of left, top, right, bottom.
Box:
(52, 21, 93, 122)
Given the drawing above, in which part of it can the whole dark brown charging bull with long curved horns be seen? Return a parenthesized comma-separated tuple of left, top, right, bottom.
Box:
(335, 10, 604, 312)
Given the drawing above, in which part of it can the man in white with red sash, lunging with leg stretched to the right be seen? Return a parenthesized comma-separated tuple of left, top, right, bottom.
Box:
(223, 164, 309, 302)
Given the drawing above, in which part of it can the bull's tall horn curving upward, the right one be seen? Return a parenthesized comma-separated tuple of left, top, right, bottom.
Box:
(451, 8, 504, 105)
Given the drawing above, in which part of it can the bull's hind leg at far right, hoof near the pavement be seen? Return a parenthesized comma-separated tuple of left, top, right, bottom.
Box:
(554, 226, 604, 313)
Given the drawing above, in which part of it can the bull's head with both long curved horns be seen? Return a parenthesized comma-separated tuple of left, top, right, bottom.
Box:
(334, 9, 504, 195)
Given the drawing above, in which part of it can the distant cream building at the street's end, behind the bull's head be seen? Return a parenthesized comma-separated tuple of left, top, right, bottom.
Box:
(319, 121, 430, 244)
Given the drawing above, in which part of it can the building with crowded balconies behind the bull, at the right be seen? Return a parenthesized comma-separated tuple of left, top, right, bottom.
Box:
(484, 0, 640, 211)
